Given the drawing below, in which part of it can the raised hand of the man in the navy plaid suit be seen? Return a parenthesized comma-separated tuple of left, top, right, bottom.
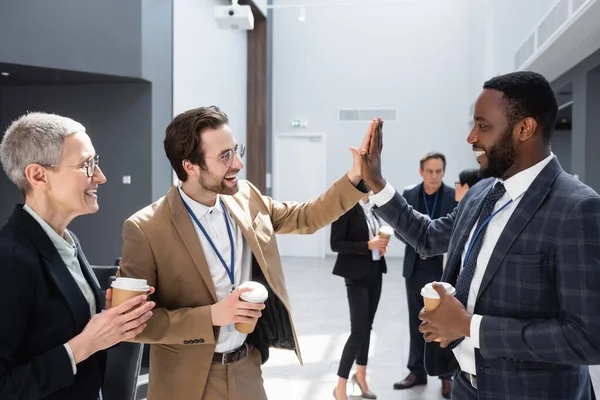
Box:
(360, 118, 386, 193)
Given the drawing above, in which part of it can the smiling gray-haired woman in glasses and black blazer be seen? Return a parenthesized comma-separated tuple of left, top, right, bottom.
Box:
(0, 113, 154, 400)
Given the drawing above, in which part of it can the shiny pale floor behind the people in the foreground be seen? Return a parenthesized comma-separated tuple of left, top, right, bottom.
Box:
(140, 258, 600, 400)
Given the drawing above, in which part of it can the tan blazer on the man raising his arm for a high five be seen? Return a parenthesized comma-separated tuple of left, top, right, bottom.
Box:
(119, 176, 364, 400)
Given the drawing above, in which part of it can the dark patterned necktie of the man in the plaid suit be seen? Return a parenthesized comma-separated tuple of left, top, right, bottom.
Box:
(456, 182, 506, 307)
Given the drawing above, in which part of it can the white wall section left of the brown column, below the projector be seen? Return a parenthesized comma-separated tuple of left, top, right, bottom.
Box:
(173, 0, 247, 178)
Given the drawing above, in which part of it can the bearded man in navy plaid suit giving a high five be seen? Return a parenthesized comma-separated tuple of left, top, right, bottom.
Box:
(361, 72, 600, 400)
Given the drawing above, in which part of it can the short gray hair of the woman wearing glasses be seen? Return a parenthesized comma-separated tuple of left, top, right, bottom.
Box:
(0, 112, 85, 193)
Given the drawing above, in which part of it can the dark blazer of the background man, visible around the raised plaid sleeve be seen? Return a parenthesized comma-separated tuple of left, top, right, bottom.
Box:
(396, 184, 458, 278)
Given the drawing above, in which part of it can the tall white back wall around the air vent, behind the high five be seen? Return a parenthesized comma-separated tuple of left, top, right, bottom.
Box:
(273, 0, 476, 256)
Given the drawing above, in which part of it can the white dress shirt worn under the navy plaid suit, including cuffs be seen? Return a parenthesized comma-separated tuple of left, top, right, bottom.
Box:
(373, 153, 554, 375)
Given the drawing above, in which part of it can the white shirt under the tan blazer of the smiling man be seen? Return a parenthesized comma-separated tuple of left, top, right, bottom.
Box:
(179, 187, 252, 353)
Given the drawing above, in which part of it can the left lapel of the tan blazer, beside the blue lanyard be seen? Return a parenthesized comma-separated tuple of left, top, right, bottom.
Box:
(167, 186, 217, 302)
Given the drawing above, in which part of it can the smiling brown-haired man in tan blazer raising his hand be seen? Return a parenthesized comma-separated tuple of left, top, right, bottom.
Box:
(119, 107, 376, 400)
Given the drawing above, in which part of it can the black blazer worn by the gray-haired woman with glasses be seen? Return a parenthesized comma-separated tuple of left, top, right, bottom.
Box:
(0, 204, 106, 400)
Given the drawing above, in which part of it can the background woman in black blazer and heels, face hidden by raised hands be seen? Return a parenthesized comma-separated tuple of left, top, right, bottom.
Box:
(331, 192, 389, 400)
